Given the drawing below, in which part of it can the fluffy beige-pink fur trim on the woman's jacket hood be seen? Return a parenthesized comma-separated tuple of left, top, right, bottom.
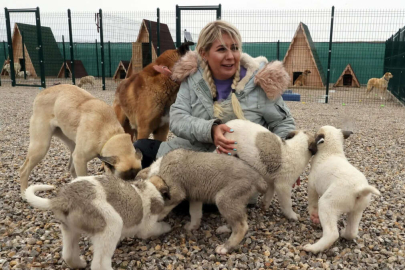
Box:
(171, 51, 290, 100)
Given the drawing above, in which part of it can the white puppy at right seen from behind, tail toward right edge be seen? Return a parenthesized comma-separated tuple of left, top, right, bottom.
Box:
(304, 126, 380, 253)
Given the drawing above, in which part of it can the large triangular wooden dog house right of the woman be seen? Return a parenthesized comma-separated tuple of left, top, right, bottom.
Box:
(283, 22, 326, 87)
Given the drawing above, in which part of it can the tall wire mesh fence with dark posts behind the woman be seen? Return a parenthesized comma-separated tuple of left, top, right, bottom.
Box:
(0, 6, 405, 105)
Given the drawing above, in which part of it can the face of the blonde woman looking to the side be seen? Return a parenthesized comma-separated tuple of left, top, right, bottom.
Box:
(201, 34, 240, 80)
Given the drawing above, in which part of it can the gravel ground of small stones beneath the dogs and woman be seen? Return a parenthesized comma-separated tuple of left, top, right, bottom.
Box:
(0, 86, 405, 270)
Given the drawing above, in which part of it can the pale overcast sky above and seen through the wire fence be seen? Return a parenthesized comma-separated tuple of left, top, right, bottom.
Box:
(0, 0, 405, 43)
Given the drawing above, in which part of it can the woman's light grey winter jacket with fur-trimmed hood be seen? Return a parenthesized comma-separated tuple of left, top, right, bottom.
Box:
(157, 52, 295, 158)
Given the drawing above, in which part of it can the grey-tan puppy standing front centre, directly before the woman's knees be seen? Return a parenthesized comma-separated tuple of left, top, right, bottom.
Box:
(136, 149, 267, 254)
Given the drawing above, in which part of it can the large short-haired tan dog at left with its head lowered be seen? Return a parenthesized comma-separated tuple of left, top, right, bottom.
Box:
(20, 84, 142, 196)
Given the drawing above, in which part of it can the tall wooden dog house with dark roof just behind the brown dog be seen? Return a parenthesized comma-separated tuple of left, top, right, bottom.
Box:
(126, 19, 176, 78)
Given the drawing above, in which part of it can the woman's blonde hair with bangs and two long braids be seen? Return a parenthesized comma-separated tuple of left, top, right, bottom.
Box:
(196, 21, 245, 119)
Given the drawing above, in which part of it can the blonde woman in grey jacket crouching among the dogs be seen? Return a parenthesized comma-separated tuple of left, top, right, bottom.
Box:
(135, 21, 295, 167)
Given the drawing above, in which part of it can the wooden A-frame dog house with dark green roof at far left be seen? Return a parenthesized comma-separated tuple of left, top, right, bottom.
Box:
(12, 23, 63, 77)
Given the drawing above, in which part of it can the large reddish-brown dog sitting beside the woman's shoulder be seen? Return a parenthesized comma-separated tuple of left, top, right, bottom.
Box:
(113, 42, 194, 141)
